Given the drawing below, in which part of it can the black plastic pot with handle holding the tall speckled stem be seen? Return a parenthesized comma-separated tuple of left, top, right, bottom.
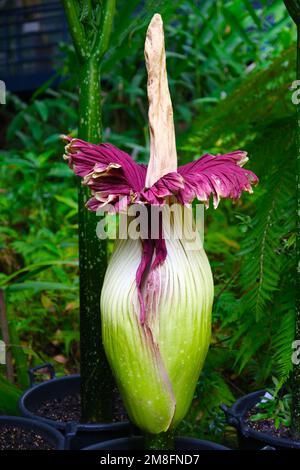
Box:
(19, 364, 133, 450)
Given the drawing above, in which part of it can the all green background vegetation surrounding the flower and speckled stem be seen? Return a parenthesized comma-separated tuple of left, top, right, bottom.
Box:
(0, 0, 296, 442)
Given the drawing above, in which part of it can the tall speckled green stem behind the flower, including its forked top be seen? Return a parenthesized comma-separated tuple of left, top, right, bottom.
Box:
(63, 0, 115, 422)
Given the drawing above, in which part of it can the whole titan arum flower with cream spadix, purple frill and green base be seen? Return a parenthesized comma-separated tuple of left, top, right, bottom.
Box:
(61, 14, 257, 434)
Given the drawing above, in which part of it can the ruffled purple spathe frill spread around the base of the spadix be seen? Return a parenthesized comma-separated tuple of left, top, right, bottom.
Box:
(64, 137, 258, 211)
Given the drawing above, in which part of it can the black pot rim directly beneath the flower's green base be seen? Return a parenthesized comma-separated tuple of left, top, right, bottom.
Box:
(82, 437, 230, 450)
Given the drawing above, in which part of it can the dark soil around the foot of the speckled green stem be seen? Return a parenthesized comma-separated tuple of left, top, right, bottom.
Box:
(35, 392, 128, 423)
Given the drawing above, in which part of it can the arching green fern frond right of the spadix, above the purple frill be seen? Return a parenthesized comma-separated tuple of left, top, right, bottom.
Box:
(181, 48, 295, 165)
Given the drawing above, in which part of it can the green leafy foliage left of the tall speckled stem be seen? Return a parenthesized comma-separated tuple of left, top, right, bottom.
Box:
(0, 90, 78, 392)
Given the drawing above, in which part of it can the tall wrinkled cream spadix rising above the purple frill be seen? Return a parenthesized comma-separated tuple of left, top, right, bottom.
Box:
(145, 13, 177, 188)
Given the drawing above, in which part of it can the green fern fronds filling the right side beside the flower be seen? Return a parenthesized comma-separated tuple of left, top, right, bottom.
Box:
(184, 44, 296, 436)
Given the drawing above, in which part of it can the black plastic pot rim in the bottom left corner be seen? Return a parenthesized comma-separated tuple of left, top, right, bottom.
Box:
(0, 416, 65, 450)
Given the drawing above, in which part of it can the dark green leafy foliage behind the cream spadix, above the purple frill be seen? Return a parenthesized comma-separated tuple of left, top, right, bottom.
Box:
(61, 0, 295, 161)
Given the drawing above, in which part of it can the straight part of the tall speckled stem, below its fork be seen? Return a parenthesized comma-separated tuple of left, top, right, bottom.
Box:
(78, 58, 113, 422)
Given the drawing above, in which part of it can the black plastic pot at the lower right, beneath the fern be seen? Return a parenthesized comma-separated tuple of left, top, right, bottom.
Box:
(221, 390, 300, 450)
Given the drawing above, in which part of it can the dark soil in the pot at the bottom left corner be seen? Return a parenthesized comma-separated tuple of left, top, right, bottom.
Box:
(0, 423, 55, 450)
